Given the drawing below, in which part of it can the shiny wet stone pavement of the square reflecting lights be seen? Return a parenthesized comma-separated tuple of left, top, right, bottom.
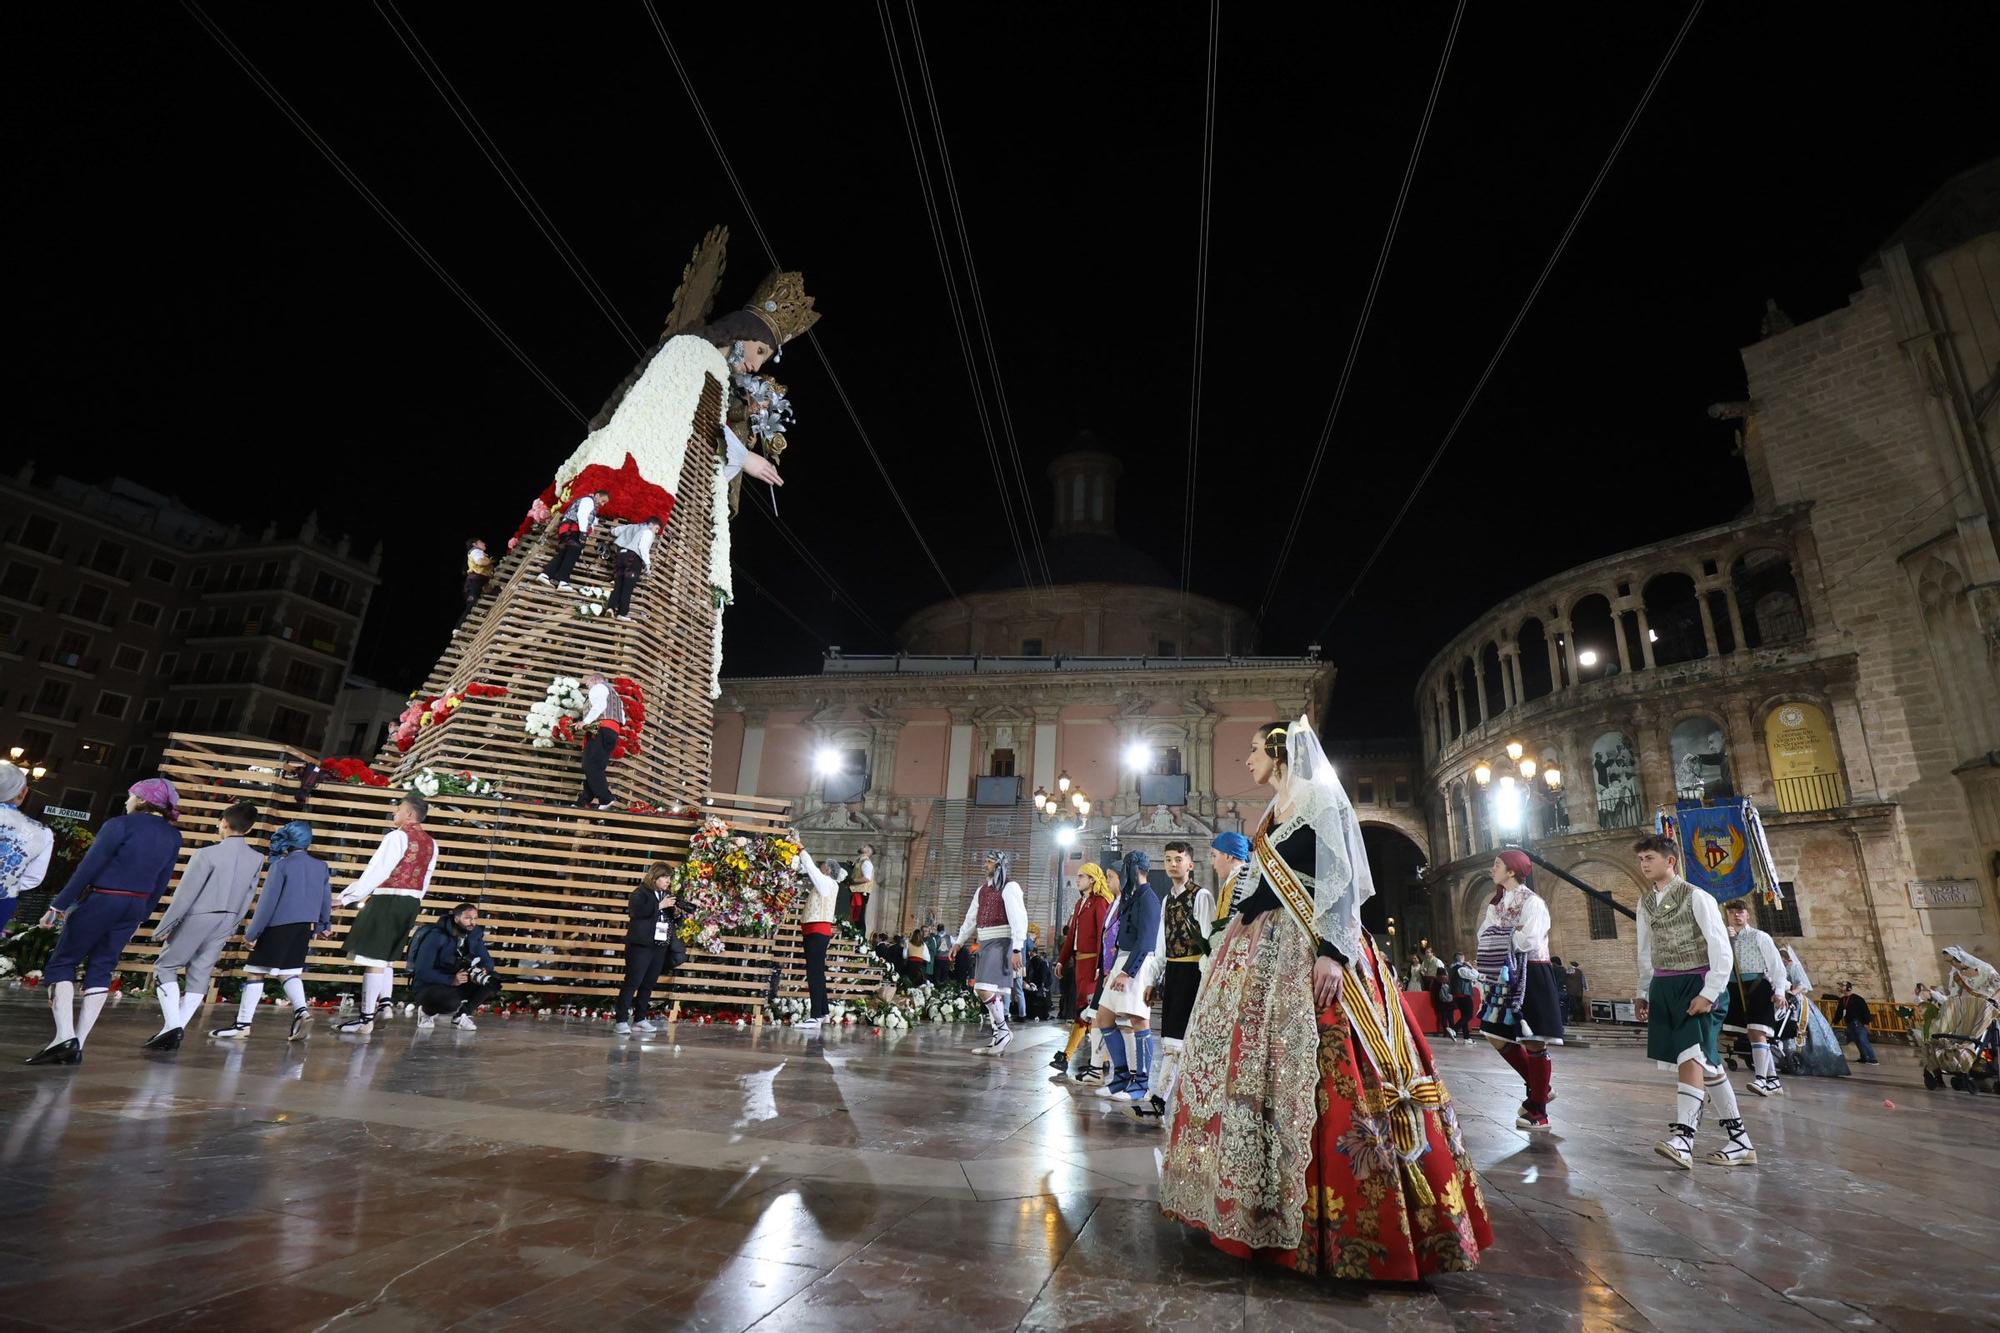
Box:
(0, 991, 2000, 1333)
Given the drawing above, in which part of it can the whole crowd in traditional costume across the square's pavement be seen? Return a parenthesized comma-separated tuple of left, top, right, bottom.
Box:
(0, 736, 2000, 1281)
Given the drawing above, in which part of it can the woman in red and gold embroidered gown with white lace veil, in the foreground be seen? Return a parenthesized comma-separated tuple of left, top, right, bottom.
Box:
(1160, 719, 1492, 1281)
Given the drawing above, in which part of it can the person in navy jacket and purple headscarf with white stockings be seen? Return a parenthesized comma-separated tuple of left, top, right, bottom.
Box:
(28, 779, 180, 1065)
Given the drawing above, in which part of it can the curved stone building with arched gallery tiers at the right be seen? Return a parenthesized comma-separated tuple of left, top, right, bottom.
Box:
(1416, 162, 2000, 999)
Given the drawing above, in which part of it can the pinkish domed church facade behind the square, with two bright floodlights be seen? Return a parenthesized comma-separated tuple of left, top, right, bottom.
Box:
(714, 450, 1328, 939)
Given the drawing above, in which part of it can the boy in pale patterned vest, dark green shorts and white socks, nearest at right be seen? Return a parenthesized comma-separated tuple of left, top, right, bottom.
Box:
(1632, 835, 1756, 1171)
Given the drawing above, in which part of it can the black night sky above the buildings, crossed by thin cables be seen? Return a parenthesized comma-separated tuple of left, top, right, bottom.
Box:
(19, 0, 1994, 735)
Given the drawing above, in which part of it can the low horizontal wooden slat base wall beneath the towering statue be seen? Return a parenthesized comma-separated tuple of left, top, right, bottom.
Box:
(122, 728, 886, 1013)
